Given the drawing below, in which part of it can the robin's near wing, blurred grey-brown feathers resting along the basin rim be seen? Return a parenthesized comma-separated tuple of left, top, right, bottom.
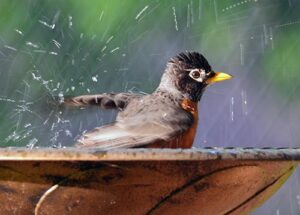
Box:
(77, 112, 193, 150)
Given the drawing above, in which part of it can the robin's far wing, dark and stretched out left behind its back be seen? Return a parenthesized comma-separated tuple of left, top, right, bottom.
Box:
(63, 93, 142, 110)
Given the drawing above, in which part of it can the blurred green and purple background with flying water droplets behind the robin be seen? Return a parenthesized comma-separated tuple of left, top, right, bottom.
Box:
(0, 0, 300, 214)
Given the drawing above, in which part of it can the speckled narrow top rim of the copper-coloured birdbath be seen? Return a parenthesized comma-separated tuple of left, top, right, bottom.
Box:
(0, 147, 300, 162)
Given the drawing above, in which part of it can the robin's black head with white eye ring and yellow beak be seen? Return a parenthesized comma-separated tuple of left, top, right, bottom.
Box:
(159, 52, 232, 102)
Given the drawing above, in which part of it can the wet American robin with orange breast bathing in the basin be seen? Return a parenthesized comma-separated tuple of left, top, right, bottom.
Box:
(65, 52, 232, 150)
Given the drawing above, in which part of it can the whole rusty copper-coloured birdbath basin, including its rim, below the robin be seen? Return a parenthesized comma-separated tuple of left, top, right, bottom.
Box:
(0, 148, 300, 215)
